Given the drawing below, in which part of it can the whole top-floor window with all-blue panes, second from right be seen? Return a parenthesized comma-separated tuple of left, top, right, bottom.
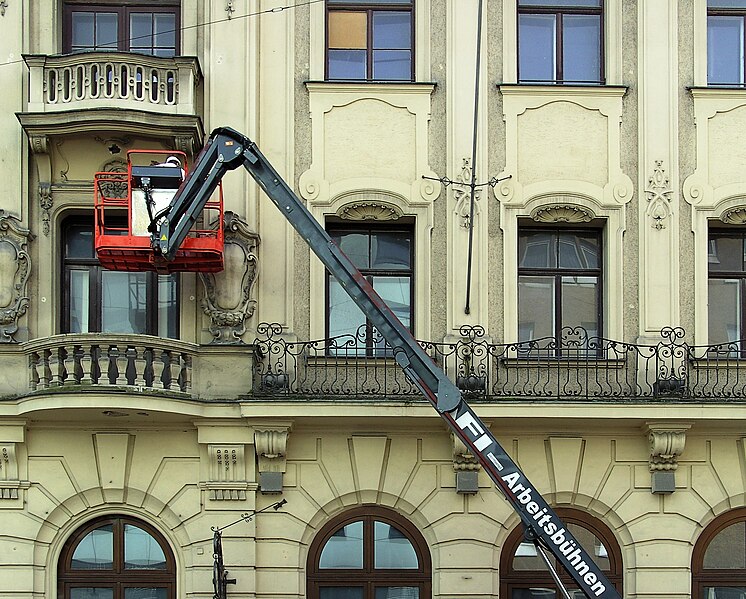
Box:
(518, 0, 604, 84)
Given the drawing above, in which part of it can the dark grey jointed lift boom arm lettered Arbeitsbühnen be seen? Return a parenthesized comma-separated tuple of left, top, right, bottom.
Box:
(151, 127, 620, 599)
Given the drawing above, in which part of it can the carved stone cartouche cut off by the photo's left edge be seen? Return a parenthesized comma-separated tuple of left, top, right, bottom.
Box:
(0, 208, 32, 343)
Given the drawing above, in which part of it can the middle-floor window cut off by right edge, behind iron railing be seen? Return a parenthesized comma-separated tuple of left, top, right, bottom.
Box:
(707, 230, 746, 349)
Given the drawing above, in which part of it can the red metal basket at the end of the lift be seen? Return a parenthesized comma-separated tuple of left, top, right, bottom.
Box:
(94, 150, 223, 274)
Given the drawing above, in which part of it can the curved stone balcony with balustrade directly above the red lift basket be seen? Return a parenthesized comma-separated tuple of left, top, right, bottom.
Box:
(17, 52, 204, 148)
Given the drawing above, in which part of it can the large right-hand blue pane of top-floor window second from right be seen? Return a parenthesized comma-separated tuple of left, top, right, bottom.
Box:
(562, 15, 601, 82)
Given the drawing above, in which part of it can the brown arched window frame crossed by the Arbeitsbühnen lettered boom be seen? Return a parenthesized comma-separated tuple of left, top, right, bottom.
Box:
(500, 507, 624, 599)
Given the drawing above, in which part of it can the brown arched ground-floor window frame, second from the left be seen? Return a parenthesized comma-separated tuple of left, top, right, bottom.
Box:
(306, 505, 432, 599)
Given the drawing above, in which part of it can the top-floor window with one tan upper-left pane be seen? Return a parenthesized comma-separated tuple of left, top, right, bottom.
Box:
(326, 0, 414, 81)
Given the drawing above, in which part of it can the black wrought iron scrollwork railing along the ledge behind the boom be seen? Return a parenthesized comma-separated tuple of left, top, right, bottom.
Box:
(253, 323, 746, 401)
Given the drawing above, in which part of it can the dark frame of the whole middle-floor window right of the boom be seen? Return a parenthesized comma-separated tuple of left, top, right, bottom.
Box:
(516, 224, 605, 350)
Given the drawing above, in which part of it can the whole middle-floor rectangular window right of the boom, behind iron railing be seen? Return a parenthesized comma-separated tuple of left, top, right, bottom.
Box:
(518, 228, 602, 352)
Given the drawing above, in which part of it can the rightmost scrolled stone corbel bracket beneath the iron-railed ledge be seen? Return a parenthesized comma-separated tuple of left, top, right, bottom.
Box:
(644, 422, 692, 494)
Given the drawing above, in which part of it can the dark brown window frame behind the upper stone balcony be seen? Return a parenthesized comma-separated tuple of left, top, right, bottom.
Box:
(62, 0, 181, 56)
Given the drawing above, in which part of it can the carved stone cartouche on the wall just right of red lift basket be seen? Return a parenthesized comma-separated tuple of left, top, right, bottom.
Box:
(200, 212, 259, 344)
